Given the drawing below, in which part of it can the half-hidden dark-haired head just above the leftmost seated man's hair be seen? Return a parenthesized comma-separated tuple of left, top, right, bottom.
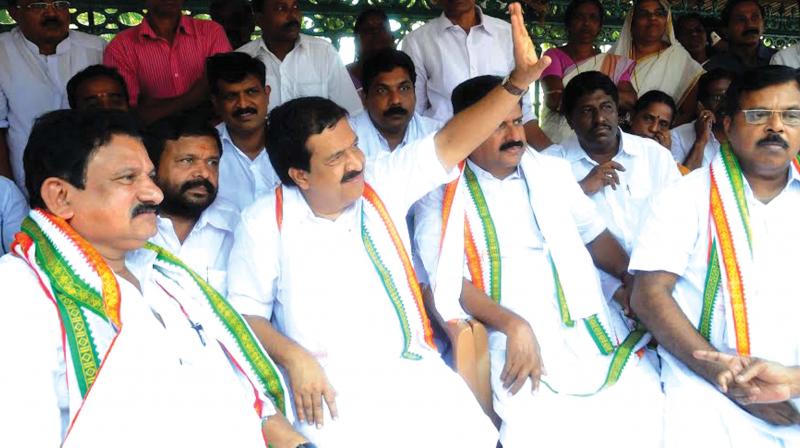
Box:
(67, 64, 128, 111)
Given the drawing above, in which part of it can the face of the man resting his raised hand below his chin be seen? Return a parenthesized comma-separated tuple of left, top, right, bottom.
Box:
(567, 90, 619, 151)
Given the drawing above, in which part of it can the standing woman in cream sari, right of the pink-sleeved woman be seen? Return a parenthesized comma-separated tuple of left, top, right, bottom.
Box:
(611, 0, 705, 126)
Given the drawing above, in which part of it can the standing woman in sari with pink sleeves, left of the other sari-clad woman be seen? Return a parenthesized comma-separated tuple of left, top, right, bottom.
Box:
(540, 0, 636, 143)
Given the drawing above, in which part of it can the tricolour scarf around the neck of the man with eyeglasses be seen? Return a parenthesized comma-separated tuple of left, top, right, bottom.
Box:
(698, 143, 800, 356)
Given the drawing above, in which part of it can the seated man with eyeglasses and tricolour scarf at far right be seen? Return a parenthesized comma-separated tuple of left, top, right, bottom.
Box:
(629, 66, 800, 448)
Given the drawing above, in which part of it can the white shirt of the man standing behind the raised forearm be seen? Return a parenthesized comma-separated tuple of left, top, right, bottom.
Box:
(400, 8, 536, 123)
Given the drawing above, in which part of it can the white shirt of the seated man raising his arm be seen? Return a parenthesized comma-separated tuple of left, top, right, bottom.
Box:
(228, 135, 458, 366)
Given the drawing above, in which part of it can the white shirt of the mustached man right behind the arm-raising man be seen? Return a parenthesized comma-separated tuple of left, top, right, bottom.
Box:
(349, 110, 442, 158)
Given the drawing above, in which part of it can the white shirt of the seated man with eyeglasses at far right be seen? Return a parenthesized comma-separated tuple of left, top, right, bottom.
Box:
(629, 168, 800, 428)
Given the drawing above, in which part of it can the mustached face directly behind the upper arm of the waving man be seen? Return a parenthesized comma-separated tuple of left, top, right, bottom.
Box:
(366, 67, 417, 133)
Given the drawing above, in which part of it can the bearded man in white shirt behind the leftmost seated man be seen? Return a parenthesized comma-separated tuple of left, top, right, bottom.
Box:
(145, 113, 240, 297)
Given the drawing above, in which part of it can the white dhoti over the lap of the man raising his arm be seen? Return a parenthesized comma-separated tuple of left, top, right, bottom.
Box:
(297, 358, 497, 448)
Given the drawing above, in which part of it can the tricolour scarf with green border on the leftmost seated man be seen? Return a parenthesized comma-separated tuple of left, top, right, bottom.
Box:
(12, 209, 286, 428)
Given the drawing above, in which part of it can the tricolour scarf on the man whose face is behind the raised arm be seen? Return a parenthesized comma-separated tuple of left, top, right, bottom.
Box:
(432, 153, 644, 395)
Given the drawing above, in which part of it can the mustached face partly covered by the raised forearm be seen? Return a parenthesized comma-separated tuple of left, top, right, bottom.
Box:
(469, 105, 525, 179)
